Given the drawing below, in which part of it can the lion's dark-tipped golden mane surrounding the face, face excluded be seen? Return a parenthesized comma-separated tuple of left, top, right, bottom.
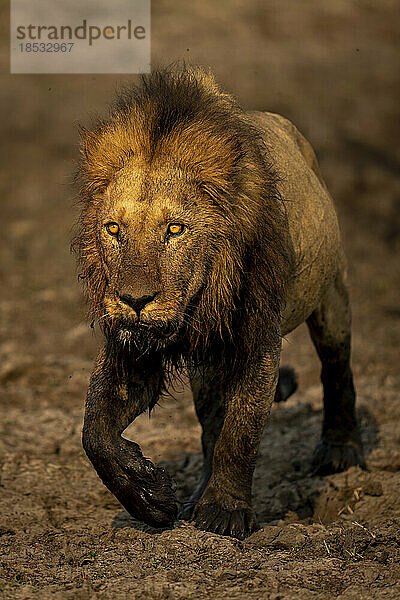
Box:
(74, 67, 293, 376)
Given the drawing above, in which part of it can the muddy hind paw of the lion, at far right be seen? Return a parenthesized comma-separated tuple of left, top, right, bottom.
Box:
(312, 440, 366, 475)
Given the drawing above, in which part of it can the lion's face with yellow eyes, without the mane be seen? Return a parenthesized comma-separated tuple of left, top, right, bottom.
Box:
(97, 163, 222, 349)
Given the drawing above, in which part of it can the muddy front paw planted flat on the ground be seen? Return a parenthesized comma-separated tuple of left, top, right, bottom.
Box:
(193, 503, 258, 540)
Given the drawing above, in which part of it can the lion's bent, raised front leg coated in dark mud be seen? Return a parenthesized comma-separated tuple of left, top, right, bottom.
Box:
(82, 350, 177, 526)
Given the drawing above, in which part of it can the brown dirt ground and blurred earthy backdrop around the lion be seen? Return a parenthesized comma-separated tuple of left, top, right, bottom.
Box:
(0, 0, 400, 600)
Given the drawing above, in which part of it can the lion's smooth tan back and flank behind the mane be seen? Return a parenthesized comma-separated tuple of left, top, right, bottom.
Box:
(249, 112, 344, 333)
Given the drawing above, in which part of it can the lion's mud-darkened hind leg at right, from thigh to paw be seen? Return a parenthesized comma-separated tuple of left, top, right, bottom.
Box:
(307, 272, 365, 475)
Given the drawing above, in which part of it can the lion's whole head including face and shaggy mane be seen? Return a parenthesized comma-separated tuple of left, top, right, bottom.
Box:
(75, 68, 288, 364)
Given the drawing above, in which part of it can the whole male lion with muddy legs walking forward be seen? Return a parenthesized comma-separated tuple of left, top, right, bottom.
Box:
(75, 68, 364, 538)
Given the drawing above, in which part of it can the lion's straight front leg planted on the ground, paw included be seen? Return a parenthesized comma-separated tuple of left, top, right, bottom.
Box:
(193, 344, 280, 539)
